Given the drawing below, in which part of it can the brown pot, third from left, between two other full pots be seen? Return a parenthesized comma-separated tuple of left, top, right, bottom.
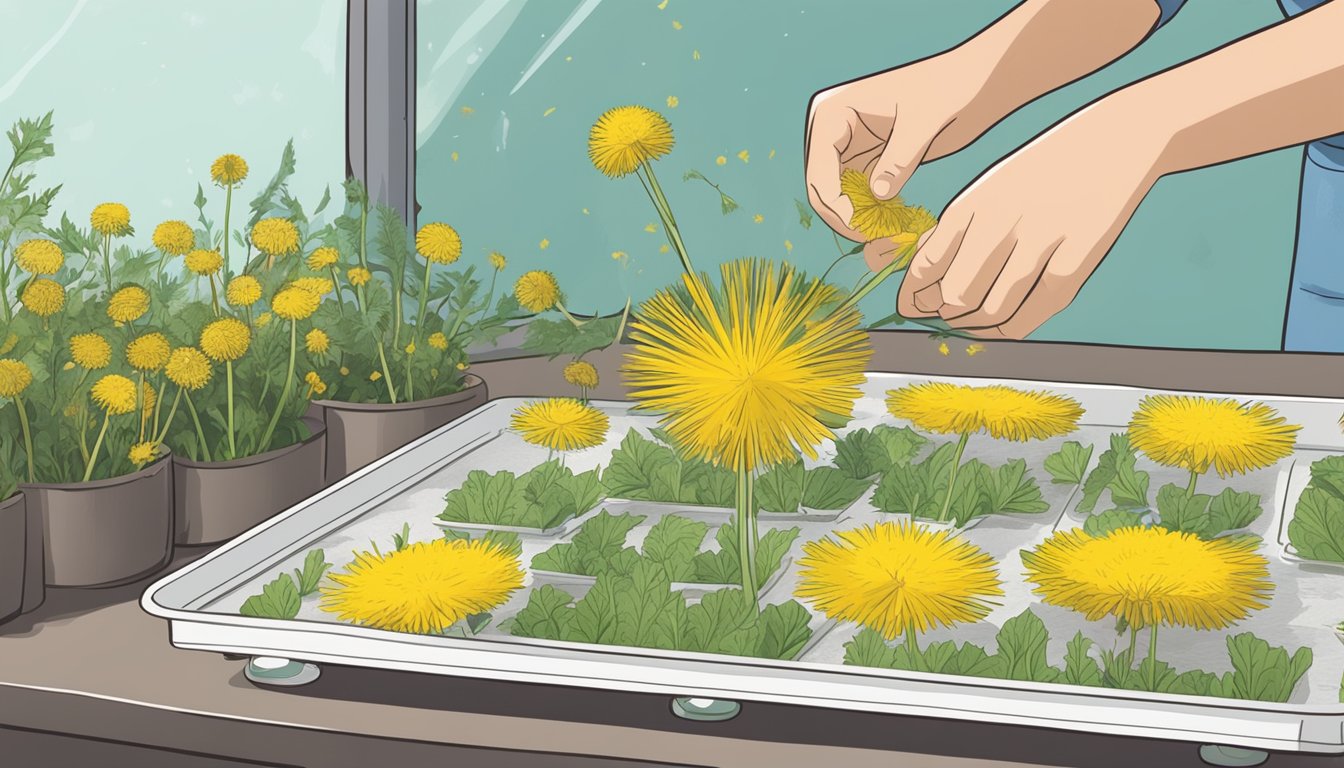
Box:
(172, 416, 327, 545)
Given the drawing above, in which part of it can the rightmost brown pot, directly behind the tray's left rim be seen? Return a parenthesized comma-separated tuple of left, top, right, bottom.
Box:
(309, 374, 489, 483)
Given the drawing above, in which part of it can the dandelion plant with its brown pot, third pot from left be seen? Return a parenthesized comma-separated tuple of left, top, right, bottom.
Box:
(156, 145, 335, 545)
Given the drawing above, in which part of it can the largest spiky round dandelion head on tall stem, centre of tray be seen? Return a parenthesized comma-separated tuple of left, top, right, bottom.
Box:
(625, 260, 871, 471)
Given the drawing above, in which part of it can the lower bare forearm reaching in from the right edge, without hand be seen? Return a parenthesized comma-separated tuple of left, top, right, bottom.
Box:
(1097, 1, 1344, 176)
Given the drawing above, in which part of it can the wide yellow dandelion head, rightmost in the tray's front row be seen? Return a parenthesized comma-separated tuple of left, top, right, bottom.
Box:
(1021, 526, 1274, 629)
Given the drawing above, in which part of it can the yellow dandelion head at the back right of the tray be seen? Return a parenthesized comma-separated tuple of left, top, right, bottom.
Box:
(1129, 394, 1301, 477)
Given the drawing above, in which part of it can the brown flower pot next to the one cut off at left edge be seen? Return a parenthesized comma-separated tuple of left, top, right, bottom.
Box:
(20, 456, 173, 586)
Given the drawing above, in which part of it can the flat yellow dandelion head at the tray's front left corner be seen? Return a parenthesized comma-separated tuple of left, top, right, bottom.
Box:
(321, 539, 523, 633)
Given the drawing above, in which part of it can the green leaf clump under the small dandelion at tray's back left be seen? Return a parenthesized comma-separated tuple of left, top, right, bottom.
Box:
(438, 459, 603, 530)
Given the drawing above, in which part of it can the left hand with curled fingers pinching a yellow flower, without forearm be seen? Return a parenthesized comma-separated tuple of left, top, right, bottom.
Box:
(804, 48, 995, 248)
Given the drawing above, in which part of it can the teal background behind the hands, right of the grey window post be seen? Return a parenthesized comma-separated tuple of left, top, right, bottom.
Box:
(417, 0, 1301, 350)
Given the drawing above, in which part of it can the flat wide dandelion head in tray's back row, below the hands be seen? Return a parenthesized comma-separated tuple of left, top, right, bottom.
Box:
(887, 382, 1083, 443)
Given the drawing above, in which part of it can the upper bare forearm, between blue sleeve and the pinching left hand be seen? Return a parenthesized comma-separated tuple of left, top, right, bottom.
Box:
(953, 0, 1160, 139)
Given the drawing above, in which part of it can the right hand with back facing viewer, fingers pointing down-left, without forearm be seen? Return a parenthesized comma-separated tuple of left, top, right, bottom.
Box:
(896, 101, 1169, 339)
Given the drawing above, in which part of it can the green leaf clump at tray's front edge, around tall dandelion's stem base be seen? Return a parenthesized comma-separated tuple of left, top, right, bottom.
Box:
(512, 560, 812, 659)
